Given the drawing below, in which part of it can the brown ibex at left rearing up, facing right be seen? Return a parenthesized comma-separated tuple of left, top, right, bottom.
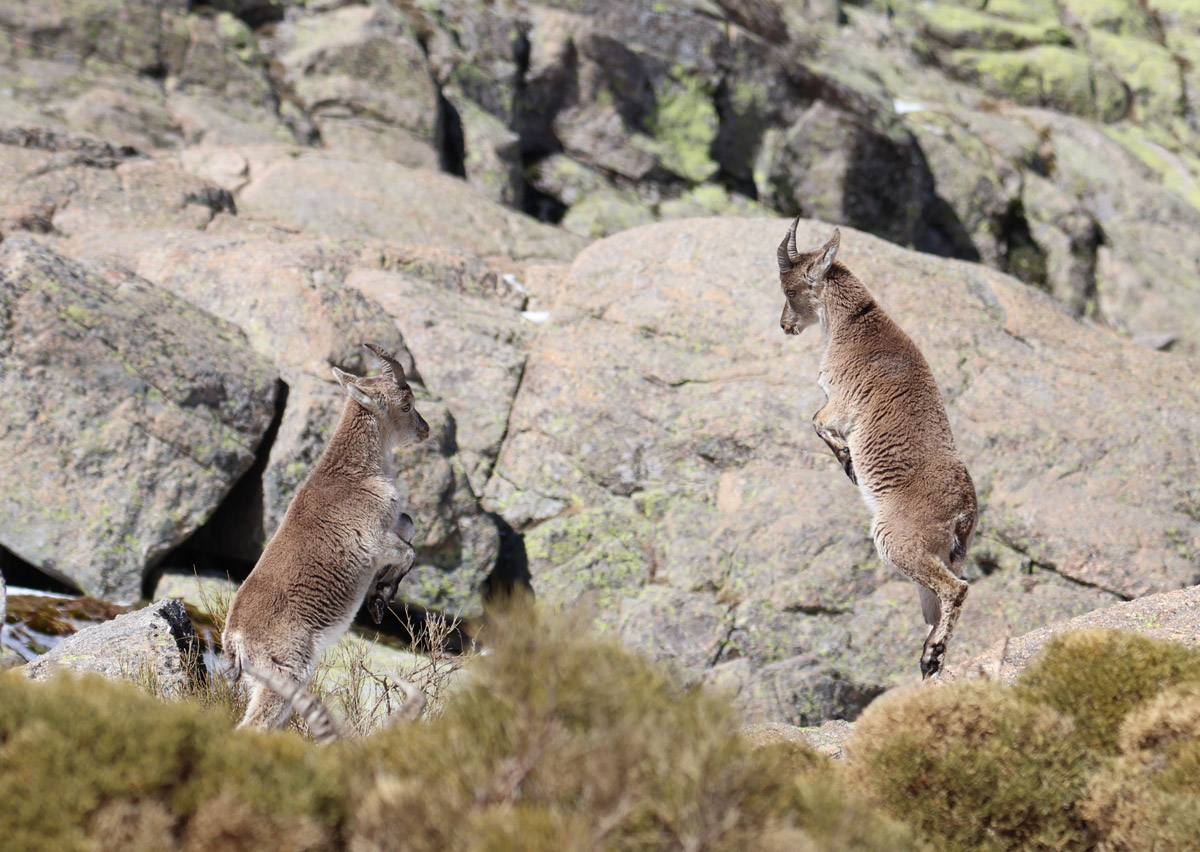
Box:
(222, 343, 430, 728)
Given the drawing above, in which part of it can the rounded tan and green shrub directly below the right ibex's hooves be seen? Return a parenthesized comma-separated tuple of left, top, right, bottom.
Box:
(846, 680, 1094, 852)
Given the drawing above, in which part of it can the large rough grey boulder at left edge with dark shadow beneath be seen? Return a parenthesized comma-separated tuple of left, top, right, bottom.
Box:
(0, 236, 276, 601)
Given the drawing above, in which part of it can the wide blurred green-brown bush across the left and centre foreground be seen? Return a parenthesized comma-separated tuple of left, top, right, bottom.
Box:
(0, 600, 913, 852)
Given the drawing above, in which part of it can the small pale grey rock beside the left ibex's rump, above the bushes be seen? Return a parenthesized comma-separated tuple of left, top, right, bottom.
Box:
(20, 600, 206, 698)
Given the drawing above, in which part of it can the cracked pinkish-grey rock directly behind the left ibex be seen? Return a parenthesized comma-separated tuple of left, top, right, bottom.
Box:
(59, 226, 511, 614)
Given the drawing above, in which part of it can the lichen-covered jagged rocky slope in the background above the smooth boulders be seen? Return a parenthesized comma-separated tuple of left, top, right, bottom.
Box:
(0, 0, 1200, 354)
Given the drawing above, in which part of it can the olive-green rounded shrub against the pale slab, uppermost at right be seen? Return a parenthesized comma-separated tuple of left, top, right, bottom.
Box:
(1015, 630, 1200, 755)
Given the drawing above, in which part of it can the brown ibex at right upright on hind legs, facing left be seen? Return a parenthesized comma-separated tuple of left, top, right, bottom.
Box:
(776, 217, 977, 678)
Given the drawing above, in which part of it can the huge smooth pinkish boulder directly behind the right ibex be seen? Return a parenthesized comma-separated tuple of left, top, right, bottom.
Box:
(485, 220, 1200, 724)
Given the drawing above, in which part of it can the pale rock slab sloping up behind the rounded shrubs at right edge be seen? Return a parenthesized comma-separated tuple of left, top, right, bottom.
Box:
(948, 586, 1200, 683)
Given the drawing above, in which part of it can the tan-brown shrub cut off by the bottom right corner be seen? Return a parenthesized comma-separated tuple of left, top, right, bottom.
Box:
(1082, 684, 1200, 852)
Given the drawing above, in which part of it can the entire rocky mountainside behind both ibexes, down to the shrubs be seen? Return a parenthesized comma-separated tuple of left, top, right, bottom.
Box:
(0, 0, 1200, 724)
